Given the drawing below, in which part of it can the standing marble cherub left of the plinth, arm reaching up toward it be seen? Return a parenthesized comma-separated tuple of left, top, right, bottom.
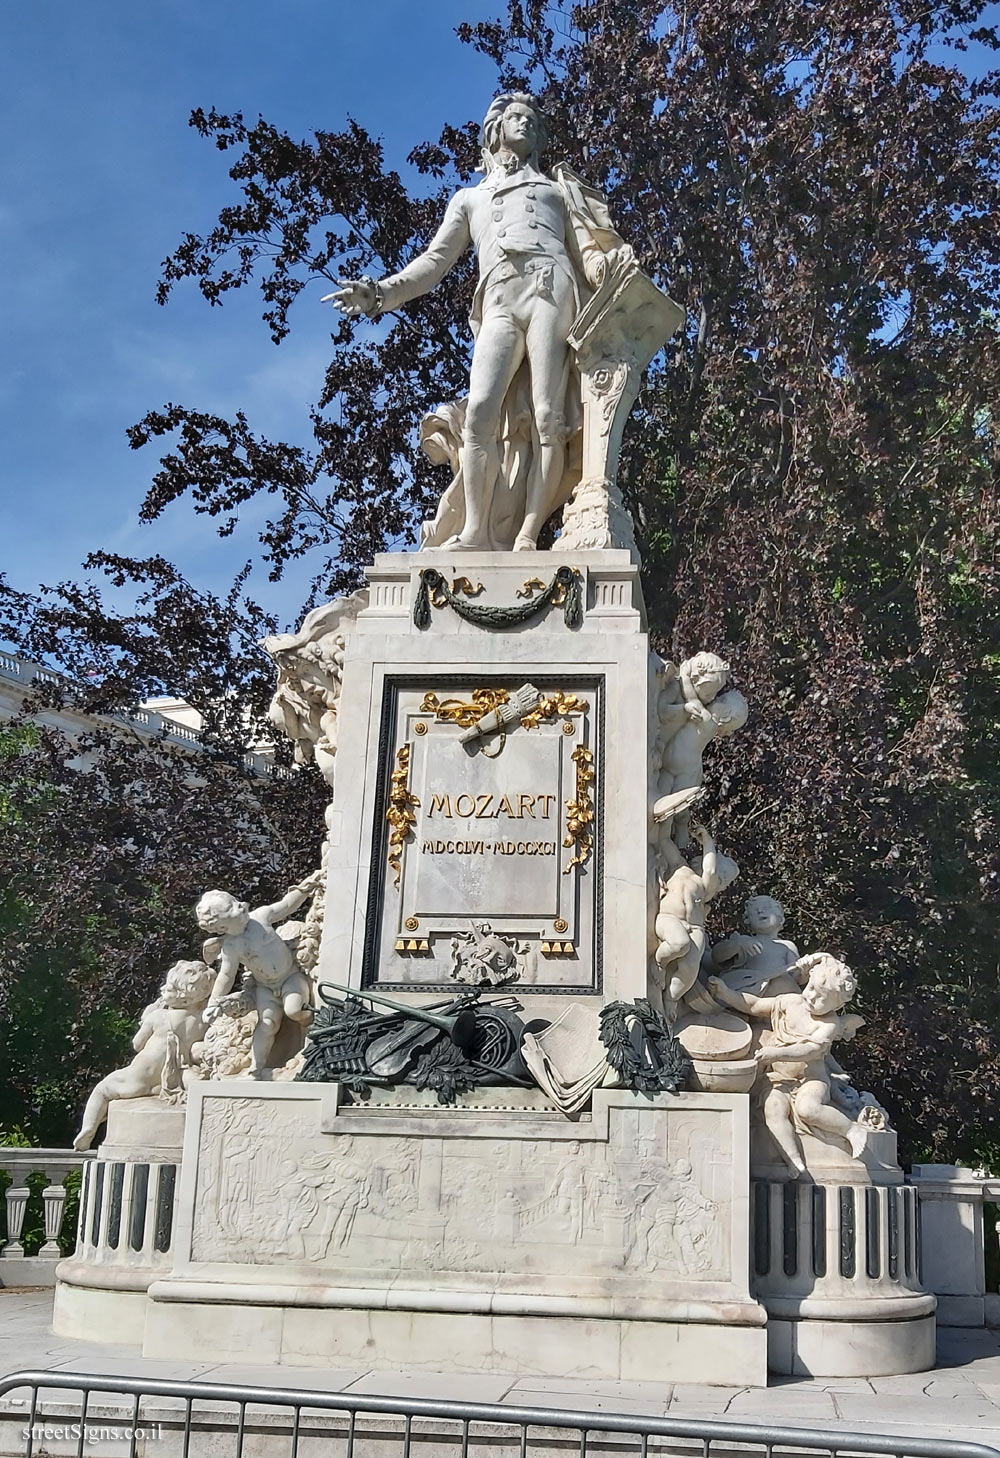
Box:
(195, 872, 322, 1077)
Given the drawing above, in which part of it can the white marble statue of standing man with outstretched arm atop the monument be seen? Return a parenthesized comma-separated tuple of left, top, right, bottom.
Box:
(327, 92, 633, 551)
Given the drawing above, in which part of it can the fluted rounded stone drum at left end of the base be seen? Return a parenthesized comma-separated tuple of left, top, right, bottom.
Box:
(52, 1098, 185, 1343)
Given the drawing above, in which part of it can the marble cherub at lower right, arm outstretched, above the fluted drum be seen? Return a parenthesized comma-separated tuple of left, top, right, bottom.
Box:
(708, 952, 869, 1175)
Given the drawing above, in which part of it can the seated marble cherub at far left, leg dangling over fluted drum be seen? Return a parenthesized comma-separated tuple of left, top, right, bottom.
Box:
(73, 962, 211, 1149)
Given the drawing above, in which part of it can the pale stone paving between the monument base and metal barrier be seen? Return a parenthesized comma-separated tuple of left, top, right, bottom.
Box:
(0, 1289, 1000, 1451)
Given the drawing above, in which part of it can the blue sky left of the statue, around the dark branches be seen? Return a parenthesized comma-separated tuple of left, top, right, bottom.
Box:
(0, 0, 506, 617)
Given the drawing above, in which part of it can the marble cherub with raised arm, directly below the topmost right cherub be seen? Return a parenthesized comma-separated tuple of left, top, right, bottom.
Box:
(650, 825, 739, 1018)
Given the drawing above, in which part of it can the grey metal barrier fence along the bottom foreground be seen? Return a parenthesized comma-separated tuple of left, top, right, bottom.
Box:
(0, 1372, 1000, 1458)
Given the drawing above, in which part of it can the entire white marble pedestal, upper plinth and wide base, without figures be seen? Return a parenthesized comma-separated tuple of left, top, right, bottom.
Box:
(47, 550, 934, 1385)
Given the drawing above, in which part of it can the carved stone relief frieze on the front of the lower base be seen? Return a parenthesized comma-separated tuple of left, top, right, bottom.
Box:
(191, 1098, 732, 1284)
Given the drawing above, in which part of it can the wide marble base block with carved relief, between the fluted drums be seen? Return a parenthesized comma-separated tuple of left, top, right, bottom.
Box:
(144, 1080, 765, 1385)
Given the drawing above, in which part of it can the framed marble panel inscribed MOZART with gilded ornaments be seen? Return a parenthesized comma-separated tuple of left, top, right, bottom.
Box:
(366, 677, 601, 991)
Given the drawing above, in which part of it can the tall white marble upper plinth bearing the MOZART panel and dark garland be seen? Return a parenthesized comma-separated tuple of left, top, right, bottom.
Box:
(319, 551, 650, 1021)
